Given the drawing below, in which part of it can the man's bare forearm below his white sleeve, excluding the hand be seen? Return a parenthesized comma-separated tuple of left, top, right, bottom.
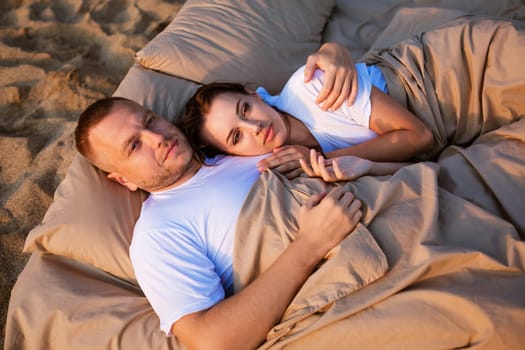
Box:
(172, 236, 324, 349)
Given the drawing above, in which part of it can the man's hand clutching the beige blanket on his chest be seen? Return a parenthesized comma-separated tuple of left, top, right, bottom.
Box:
(297, 187, 362, 256)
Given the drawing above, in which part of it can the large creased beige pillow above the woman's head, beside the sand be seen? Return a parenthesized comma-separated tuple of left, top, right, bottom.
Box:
(135, 0, 335, 93)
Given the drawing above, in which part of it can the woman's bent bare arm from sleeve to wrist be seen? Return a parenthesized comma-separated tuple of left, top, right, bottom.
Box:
(326, 87, 434, 162)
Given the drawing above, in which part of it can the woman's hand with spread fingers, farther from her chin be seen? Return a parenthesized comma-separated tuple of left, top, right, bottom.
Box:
(299, 150, 374, 182)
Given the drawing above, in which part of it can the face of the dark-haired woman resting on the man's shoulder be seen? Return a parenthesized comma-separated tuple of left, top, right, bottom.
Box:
(201, 92, 288, 156)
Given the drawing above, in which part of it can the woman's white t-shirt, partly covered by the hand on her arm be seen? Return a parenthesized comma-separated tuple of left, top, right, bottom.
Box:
(257, 63, 386, 153)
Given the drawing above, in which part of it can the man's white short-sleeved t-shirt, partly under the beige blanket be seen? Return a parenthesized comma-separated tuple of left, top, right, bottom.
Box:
(130, 156, 264, 334)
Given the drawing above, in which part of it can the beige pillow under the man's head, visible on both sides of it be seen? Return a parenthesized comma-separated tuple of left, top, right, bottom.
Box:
(24, 64, 199, 283)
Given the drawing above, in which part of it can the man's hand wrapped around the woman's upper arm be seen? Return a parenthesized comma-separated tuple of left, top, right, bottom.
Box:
(304, 43, 358, 111)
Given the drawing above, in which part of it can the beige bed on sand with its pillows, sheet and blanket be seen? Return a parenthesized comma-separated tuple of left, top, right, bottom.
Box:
(5, 0, 525, 350)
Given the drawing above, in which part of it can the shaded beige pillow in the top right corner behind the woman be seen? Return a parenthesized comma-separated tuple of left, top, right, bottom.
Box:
(323, 0, 525, 60)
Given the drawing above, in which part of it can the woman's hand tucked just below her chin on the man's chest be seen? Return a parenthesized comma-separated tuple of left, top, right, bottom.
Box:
(257, 145, 310, 179)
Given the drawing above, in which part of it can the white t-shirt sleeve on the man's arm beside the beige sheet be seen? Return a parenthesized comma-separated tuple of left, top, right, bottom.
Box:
(130, 230, 225, 335)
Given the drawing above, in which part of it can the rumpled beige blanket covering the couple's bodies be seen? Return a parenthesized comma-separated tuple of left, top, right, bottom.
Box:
(234, 19, 525, 349)
